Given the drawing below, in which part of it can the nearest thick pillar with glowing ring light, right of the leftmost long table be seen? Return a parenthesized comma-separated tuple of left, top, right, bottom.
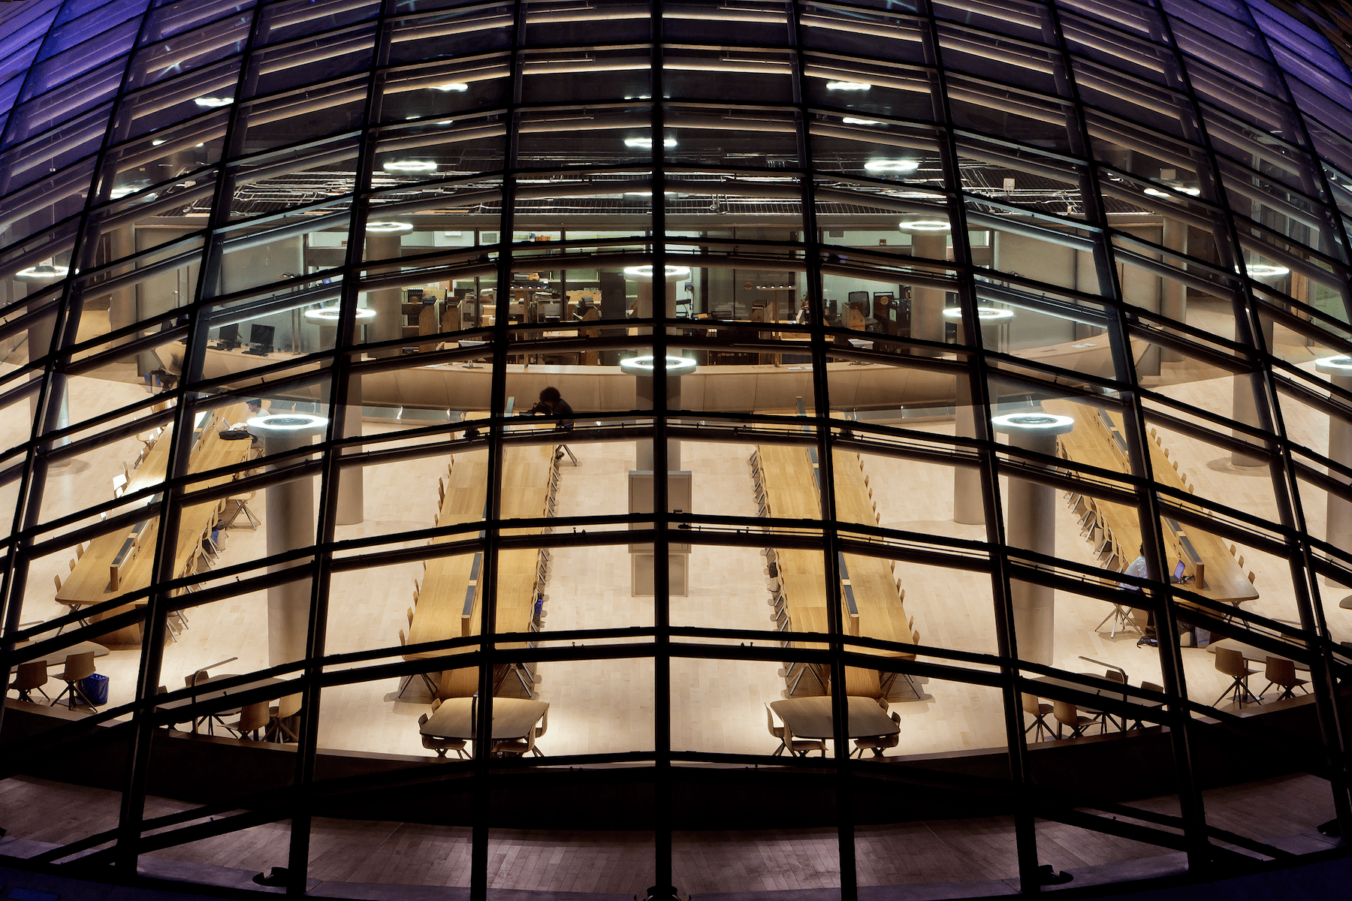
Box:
(247, 414, 329, 701)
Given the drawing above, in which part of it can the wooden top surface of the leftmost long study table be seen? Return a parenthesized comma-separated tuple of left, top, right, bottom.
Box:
(57, 403, 251, 605)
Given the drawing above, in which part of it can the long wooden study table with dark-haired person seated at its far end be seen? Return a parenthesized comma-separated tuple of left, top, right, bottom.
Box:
(404, 424, 557, 698)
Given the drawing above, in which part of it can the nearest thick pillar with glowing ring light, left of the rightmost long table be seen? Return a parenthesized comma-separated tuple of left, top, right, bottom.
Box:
(991, 413, 1075, 666)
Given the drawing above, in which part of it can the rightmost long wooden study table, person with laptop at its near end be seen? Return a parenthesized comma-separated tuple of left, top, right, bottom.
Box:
(1042, 399, 1259, 603)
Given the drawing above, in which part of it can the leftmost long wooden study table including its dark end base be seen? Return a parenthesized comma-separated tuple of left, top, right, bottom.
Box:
(57, 403, 253, 647)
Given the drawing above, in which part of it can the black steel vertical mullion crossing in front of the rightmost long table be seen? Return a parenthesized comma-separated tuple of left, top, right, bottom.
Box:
(1046, 4, 1210, 871)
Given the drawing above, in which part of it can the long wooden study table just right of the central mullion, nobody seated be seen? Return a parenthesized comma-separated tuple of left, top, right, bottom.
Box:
(757, 445, 914, 698)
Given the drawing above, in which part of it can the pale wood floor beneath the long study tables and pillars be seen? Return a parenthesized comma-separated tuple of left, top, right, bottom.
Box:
(0, 315, 1352, 754)
